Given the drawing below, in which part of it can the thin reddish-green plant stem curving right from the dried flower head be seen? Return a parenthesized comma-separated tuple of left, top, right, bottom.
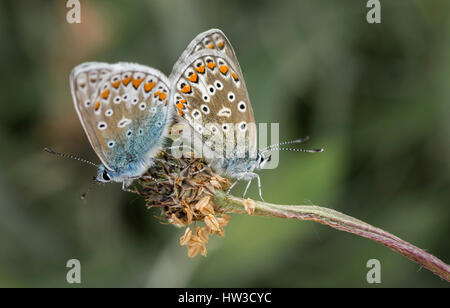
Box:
(215, 191, 450, 282)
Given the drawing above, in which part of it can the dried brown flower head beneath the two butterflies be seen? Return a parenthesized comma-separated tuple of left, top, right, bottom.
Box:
(128, 152, 231, 257)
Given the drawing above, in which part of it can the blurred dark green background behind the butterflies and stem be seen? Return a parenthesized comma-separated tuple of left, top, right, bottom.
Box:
(0, 0, 450, 287)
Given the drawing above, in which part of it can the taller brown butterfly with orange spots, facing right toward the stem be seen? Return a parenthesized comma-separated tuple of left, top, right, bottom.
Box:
(169, 29, 317, 200)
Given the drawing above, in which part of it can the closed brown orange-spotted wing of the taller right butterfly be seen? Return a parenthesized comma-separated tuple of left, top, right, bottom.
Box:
(170, 29, 256, 159)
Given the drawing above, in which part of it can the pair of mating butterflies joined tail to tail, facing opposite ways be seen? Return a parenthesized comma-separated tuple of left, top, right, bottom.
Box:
(70, 29, 322, 199)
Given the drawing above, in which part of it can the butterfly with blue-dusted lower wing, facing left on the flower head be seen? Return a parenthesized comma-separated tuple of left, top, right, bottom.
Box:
(70, 62, 171, 189)
